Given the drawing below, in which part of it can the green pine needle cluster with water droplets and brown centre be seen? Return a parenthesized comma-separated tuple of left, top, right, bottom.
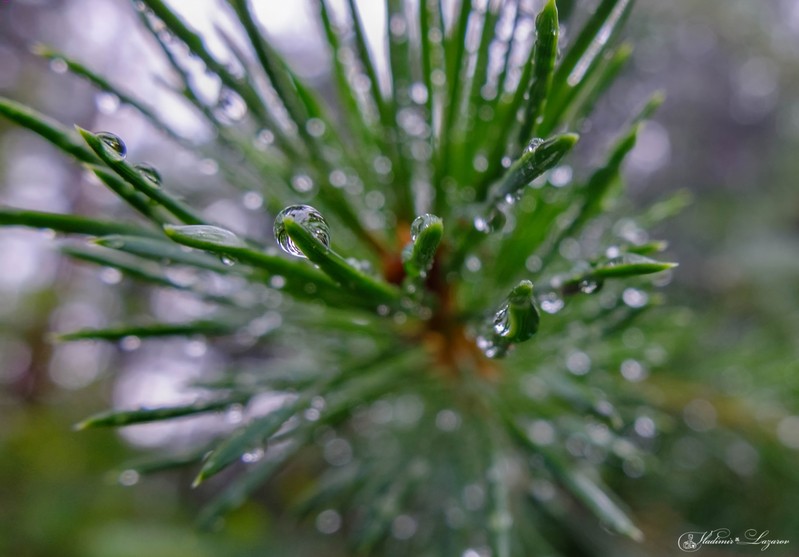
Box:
(0, 0, 674, 556)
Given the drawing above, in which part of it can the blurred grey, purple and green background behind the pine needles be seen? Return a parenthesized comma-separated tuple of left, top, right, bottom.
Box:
(0, 0, 799, 557)
